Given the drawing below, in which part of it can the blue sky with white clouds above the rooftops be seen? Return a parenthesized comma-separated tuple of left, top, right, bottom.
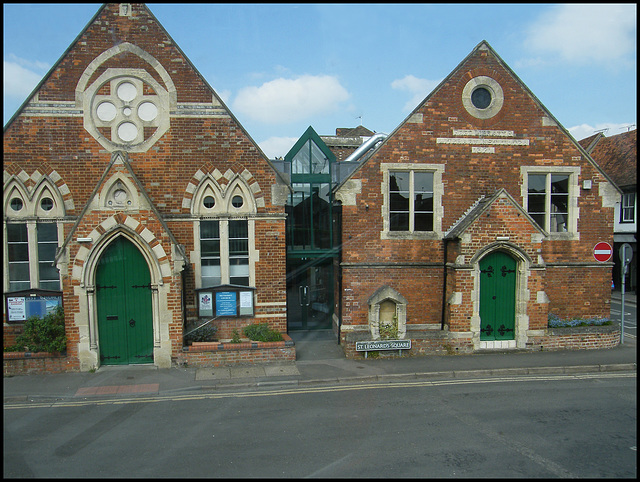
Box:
(3, 3, 637, 158)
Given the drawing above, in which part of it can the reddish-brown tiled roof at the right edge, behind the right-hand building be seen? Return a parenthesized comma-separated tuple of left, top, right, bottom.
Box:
(579, 129, 638, 189)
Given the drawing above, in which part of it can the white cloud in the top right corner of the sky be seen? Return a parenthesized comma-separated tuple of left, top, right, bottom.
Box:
(525, 4, 637, 63)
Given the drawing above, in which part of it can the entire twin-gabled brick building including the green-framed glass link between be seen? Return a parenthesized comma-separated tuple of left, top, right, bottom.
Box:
(3, 4, 620, 370)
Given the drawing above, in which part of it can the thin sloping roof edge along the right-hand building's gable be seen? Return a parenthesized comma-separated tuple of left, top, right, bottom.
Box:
(343, 40, 622, 192)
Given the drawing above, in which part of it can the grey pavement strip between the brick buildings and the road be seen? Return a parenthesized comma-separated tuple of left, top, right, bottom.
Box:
(3, 292, 637, 409)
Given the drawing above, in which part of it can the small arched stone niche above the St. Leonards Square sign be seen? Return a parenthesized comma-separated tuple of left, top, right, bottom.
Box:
(368, 286, 407, 340)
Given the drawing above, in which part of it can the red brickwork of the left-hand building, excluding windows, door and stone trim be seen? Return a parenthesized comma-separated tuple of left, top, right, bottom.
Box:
(3, 4, 286, 368)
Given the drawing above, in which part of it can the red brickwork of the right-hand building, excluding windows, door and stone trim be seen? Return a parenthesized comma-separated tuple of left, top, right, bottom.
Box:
(342, 42, 613, 336)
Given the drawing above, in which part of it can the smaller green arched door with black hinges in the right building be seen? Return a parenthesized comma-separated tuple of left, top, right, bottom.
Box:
(480, 251, 517, 341)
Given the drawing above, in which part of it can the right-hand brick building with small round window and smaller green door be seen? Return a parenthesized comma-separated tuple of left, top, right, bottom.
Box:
(334, 42, 620, 356)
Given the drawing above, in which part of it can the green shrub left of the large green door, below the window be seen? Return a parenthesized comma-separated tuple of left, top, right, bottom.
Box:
(15, 306, 67, 352)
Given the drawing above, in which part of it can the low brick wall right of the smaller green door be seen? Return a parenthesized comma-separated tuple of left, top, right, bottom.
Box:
(527, 323, 620, 351)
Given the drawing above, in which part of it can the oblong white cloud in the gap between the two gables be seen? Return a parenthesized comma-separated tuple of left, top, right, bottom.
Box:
(233, 75, 349, 124)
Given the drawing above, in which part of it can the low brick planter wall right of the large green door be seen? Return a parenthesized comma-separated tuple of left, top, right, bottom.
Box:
(174, 333, 296, 367)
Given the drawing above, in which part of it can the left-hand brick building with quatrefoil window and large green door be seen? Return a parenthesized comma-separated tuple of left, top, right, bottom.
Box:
(3, 4, 289, 370)
